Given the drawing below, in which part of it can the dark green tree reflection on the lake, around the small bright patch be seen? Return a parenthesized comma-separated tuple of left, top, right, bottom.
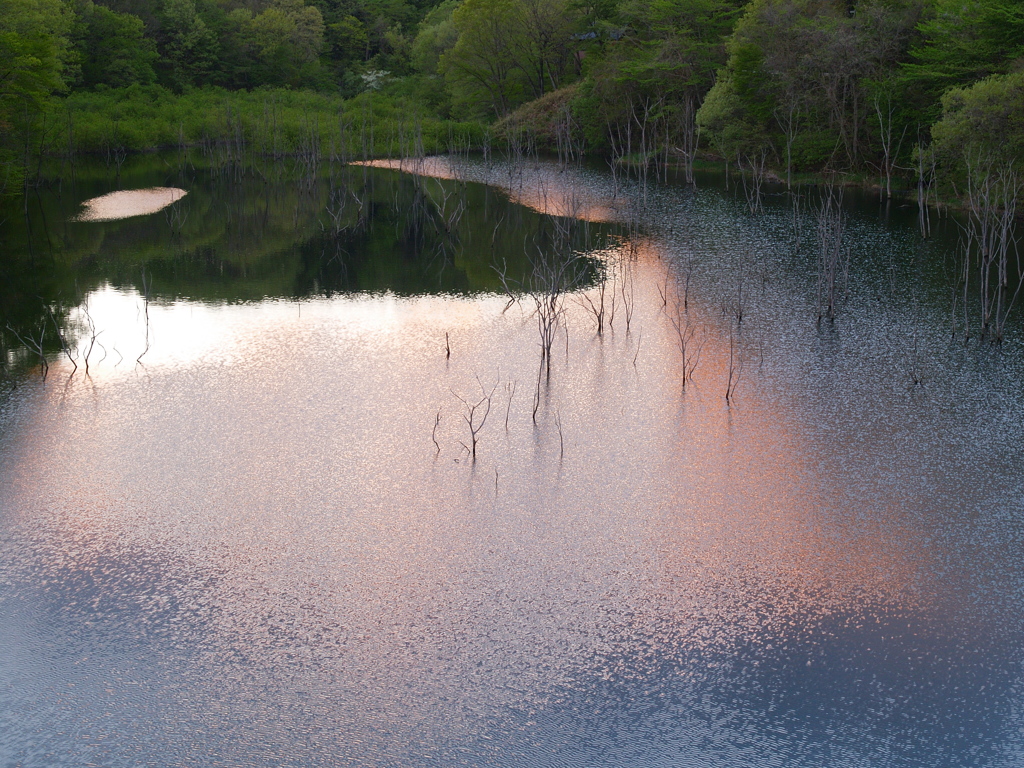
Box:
(0, 157, 604, 376)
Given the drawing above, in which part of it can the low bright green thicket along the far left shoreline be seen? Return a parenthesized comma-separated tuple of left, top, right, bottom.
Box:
(40, 84, 485, 159)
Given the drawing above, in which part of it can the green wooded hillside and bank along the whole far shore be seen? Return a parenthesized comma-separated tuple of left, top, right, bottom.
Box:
(0, 0, 1024, 201)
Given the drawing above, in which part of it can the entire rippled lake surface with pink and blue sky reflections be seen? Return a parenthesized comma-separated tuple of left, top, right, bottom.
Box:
(0, 158, 1024, 768)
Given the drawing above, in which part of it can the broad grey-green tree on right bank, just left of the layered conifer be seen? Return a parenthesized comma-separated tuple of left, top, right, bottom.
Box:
(703, 0, 921, 173)
